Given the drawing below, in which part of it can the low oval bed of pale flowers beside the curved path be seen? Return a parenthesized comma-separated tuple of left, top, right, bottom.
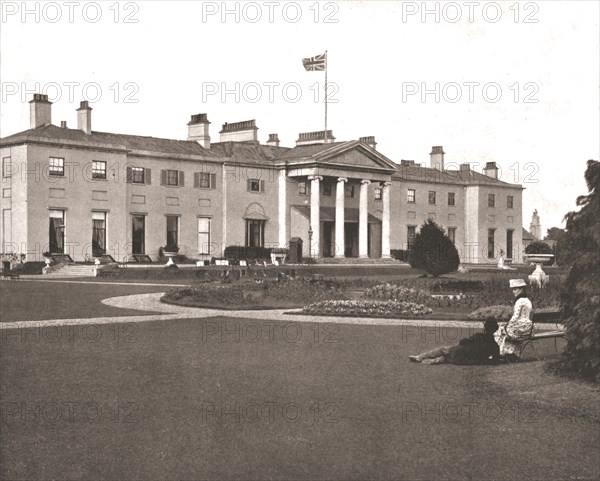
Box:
(302, 300, 433, 317)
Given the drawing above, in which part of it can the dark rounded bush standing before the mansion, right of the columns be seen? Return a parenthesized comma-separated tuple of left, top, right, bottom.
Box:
(409, 220, 460, 277)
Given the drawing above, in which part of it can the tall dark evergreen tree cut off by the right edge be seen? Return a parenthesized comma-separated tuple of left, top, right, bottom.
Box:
(557, 160, 600, 382)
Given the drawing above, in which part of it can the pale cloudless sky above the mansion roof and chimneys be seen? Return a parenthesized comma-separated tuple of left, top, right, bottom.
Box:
(0, 1, 600, 232)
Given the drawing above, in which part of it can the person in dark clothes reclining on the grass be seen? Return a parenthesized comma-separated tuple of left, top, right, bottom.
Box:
(409, 318, 500, 364)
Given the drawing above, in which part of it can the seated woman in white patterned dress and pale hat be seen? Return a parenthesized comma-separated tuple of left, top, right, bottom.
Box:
(494, 279, 532, 360)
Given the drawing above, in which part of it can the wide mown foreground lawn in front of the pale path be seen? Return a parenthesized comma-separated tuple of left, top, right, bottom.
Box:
(0, 312, 600, 481)
